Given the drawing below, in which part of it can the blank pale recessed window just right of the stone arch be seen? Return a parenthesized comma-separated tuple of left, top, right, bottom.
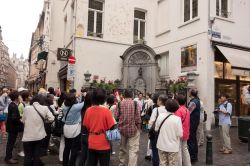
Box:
(158, 52, 169, 77)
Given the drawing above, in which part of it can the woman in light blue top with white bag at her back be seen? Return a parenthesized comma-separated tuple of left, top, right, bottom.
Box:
(63, 93, 84, 166)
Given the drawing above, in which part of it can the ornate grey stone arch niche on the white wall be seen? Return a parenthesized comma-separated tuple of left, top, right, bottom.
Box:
(121, 44, 159, 93)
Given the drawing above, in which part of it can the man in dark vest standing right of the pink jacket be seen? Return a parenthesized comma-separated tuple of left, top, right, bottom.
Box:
(187, 89, 201, 163)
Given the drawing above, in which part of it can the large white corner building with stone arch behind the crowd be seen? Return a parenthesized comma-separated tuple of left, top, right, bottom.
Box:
(59, 0, 250, 129)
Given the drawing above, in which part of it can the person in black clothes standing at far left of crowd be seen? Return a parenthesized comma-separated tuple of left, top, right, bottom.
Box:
(5, 91, 23, 164)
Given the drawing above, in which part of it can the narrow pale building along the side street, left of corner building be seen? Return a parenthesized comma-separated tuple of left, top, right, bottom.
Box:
(29, 0, 64, 91)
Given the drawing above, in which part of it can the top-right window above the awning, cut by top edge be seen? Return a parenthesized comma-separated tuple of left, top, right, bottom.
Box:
(216, 0, 229, 18)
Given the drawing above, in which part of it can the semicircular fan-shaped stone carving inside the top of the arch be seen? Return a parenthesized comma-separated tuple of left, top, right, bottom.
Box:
(128, 51, 151, 65)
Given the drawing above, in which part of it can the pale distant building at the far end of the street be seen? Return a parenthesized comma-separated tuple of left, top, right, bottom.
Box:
(10, 54, 29, 88)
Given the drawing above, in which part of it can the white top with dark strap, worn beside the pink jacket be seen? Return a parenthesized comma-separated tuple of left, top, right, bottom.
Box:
(155, 112, 183, 152)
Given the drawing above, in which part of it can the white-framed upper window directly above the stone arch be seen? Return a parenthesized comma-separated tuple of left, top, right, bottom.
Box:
(133, 9, 147, 43)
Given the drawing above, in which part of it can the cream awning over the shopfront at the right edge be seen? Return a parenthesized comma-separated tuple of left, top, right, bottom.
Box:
(216, 45, 250, 77)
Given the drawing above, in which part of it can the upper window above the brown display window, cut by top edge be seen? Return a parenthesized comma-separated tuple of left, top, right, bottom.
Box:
(184, 0, 198, 22)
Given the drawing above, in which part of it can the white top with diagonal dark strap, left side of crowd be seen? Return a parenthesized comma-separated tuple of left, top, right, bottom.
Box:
(22, 102, 55, 142)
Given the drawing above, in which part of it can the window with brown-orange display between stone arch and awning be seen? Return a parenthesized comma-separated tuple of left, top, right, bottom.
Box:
(181, 45, 197, 71)
